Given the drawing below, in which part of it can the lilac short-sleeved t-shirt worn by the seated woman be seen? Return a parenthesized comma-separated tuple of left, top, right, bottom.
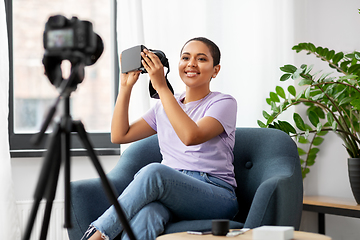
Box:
(143, 92, 237, 187)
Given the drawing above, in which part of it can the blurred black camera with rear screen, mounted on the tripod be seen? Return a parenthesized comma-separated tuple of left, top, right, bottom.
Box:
(43, 15, 104, 65)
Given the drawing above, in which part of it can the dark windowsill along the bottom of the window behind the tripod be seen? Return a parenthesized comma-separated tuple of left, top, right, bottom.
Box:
(10, 148, 120, 158)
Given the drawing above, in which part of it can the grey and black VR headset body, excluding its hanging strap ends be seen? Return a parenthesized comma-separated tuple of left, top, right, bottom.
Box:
(121, 45, 169, 73)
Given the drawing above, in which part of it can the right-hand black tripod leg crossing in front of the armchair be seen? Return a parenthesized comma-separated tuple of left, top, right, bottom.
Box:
(74, 121, 136, 240)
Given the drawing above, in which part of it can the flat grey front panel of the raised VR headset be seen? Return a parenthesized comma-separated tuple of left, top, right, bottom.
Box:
(121, 45, 146, 73)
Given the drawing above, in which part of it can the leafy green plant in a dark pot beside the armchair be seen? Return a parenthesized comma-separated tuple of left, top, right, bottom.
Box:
(258, 43, 360, 203)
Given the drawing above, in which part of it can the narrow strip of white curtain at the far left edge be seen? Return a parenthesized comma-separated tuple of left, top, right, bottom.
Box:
(0, 1, 20, 240)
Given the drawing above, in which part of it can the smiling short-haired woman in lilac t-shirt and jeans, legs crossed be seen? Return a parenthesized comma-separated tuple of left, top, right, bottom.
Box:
(87, 38, 238, 240)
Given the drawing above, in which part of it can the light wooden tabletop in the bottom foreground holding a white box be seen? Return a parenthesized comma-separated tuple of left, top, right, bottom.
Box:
(156, 230, 331, 240)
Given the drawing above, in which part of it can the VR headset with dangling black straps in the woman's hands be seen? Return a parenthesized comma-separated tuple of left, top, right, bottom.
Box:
(121, 45, 174, 99)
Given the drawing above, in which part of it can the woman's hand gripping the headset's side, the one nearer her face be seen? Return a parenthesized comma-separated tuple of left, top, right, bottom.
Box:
(141, 49, 167, 91)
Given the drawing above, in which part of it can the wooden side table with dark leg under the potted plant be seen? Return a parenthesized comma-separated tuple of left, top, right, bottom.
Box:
(303, 196, 360, 234)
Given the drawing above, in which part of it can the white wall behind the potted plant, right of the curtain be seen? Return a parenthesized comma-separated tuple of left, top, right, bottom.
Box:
(294, 0, 360, 240)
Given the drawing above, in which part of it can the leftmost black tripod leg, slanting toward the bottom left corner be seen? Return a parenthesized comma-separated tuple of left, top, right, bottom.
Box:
(23, 125, 60, 240)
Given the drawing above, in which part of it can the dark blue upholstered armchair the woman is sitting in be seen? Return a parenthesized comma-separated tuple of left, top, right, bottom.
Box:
(68, 128, 303, 240)
